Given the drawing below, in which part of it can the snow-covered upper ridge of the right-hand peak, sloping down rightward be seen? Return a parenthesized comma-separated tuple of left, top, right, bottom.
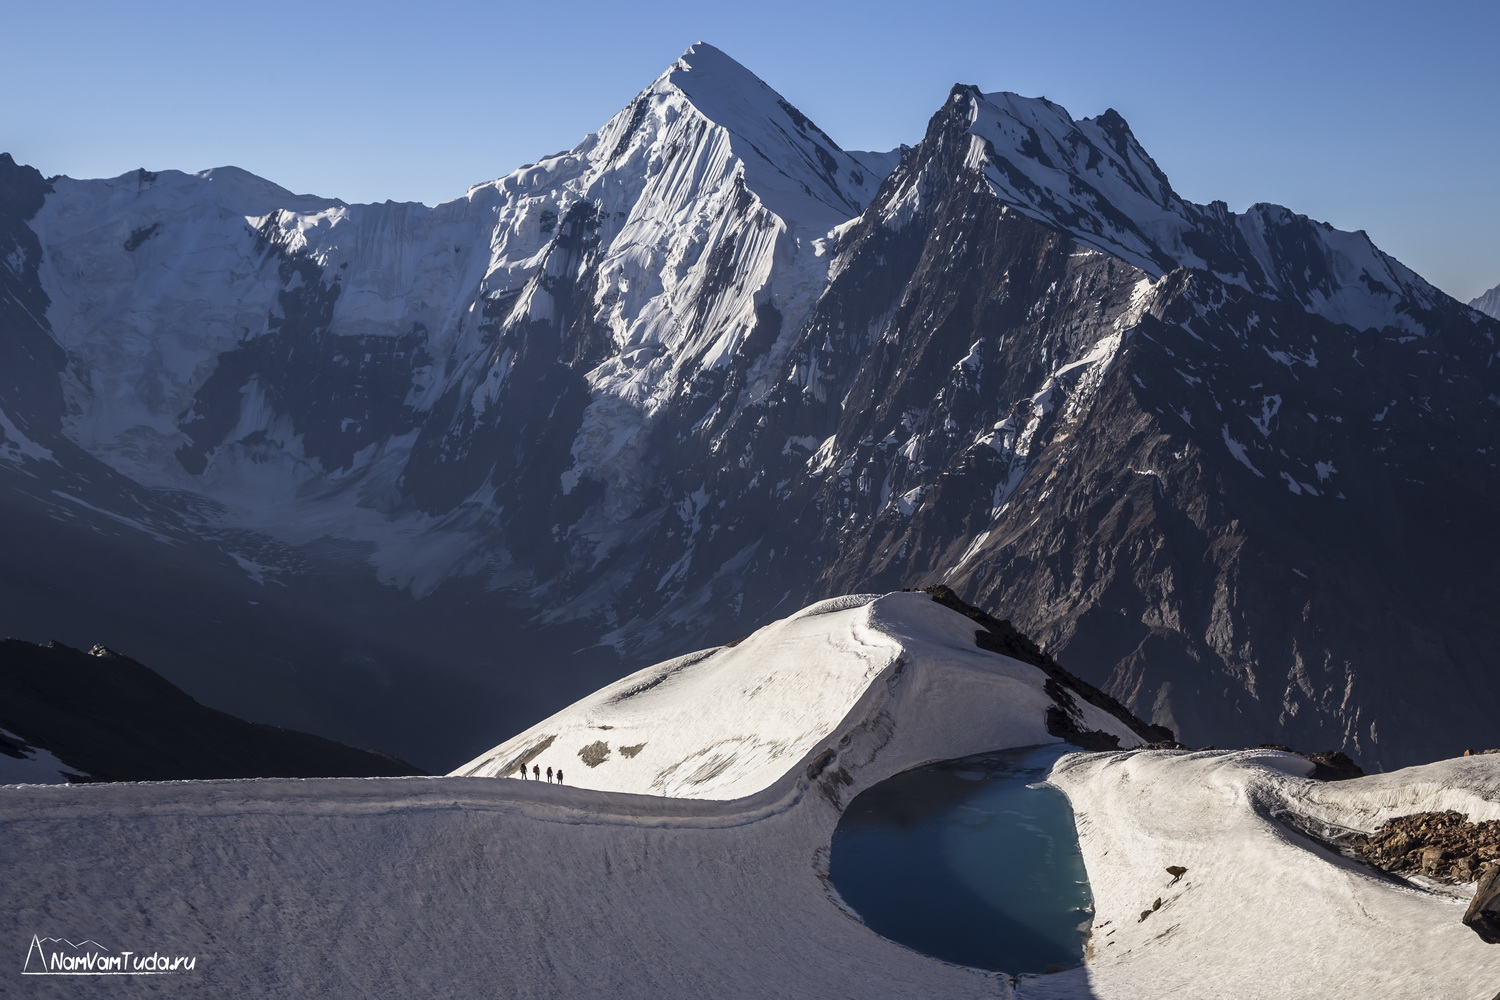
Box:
(918, 85, 1442, 333)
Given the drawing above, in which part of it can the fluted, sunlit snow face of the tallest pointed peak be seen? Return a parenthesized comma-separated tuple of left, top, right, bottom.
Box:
(492, 43, 894, 407)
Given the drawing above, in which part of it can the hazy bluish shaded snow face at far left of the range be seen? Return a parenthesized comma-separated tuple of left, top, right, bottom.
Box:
(33, 168, 336, 483)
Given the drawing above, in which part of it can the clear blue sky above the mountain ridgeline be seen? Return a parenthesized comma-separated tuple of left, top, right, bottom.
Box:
(0, 0, 1500, 300)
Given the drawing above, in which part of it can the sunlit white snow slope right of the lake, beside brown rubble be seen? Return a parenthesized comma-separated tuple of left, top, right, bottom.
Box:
(1052, 750, 1500, 1000)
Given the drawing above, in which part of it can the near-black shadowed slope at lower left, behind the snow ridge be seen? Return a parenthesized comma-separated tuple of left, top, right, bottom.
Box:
(0, 639, 426, 781)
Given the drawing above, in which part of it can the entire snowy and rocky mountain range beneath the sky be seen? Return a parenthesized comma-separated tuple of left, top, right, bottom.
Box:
(0, 45, 1500, 769)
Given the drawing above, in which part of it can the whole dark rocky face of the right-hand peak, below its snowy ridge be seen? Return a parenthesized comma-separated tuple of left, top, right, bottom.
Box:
(636, 89, 1500, 766)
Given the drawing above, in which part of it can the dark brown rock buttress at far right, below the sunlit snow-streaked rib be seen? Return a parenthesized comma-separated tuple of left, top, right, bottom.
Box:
(906, 274, 1500, 765)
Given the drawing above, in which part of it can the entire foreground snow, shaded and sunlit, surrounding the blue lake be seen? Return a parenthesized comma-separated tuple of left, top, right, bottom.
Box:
(0, 594, 1500, 1000)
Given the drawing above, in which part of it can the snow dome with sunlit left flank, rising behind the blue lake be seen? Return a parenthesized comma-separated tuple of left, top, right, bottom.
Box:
(453, 594, 1140, 799)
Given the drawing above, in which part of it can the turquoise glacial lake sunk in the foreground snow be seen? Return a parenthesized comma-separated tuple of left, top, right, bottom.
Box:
(830, 744, 1094, 975)
